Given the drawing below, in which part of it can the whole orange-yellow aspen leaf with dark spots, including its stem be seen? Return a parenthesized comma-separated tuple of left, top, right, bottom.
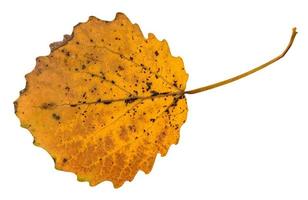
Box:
(14, 13, 296, 188)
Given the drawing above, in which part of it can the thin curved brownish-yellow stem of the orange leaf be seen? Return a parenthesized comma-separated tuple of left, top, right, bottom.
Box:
(184, 28, 297, 94)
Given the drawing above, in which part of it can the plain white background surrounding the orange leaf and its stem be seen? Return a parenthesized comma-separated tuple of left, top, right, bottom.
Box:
(0, 0, 308, 200)
